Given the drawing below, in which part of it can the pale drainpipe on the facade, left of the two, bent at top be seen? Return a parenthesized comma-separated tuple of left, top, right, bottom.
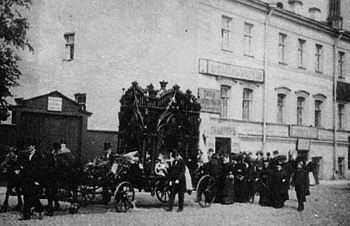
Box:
(262, 4, 276, 153)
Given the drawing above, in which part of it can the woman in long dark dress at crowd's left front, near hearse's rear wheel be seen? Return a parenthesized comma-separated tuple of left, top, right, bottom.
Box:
(222, 155, 235, 204)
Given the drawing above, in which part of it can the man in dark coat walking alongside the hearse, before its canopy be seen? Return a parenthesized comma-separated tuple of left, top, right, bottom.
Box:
(165, 150, 186, 212)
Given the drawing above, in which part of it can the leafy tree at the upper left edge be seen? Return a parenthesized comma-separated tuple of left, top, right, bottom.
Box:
(0, 0, 34, 121)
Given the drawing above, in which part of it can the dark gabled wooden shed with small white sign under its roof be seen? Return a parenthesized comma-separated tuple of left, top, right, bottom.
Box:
(11, 91, 92, 159)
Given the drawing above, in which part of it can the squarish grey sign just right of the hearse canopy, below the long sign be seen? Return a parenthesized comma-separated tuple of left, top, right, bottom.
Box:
(198, 88, 222, 114)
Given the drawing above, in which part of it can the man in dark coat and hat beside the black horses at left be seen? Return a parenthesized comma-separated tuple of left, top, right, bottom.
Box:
(20, 140, 43, 220)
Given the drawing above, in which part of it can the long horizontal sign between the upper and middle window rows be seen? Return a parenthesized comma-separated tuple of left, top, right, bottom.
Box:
(199, 59, 264, 82)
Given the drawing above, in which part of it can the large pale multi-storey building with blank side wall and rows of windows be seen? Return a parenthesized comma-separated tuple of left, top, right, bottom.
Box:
(9, 0, 350, 179)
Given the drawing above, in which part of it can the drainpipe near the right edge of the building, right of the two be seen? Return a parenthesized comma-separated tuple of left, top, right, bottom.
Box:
(332, 30, 344, 180)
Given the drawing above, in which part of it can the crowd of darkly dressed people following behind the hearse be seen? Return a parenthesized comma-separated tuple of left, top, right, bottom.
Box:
(198, 150, 314, 211)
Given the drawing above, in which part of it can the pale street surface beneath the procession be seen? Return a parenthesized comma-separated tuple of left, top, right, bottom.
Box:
(0, 181, 350, 226)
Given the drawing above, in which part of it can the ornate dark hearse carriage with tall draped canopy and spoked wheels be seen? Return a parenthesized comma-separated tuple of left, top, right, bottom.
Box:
(0, 81, 217, 214)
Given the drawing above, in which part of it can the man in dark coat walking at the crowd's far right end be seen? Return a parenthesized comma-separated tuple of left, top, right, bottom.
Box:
(292, 161, 309, 211)
